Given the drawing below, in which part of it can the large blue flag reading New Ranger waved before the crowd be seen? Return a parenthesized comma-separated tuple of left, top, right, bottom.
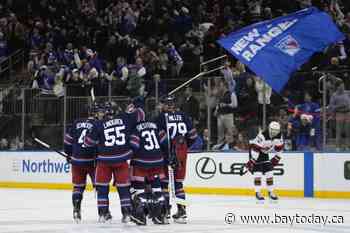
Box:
(218, 7, 345, 92)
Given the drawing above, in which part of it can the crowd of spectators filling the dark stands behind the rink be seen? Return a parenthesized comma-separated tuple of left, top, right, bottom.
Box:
(0, 0, 350, 151)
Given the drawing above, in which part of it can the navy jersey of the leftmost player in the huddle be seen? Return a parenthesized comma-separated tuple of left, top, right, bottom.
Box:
(64, 119, 96, 165)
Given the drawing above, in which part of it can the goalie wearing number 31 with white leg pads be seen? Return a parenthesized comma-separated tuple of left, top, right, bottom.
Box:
(130, 116, 166, 225)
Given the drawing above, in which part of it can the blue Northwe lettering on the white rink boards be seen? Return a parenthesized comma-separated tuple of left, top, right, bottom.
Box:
(21, 159, 70, 173)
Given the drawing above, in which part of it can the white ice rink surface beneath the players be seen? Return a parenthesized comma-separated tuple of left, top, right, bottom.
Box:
(0, 189, 350, 233)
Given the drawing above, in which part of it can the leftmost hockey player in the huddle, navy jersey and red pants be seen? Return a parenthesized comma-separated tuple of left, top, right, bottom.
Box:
(64, 106, 103, 222)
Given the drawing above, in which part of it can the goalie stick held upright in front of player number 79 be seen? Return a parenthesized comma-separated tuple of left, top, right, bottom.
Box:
(165, 113, 187, 206)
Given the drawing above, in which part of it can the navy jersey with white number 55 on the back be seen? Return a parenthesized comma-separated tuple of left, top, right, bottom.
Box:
(84, 114, 132, 163)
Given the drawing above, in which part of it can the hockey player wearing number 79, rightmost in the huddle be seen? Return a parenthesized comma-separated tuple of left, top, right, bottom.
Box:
(157, 96, 197, 223)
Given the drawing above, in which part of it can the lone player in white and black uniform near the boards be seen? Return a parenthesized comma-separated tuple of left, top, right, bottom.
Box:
(246, 121, 284, 201)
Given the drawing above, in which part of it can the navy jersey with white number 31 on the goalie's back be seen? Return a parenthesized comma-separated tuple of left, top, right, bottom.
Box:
(130, 121, 166, 168)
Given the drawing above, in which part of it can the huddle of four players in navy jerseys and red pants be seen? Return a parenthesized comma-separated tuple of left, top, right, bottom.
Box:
(64, 97, 197, 225)
